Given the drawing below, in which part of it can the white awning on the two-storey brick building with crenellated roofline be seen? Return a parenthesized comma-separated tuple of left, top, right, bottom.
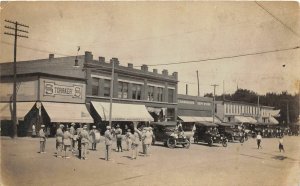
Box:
(92, 101, 154, 121)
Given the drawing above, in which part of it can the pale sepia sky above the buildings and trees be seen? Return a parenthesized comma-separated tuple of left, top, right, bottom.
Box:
(0, 1, 300, 96)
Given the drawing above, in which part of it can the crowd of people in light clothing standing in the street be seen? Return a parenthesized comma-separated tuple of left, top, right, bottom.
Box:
(34, 123, 153, 161)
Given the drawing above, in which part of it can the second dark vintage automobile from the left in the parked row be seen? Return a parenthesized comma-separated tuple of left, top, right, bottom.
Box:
(194, 122, 227, 147)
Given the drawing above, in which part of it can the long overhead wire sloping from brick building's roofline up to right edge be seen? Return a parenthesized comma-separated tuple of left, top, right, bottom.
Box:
(135, 46, 300, 67)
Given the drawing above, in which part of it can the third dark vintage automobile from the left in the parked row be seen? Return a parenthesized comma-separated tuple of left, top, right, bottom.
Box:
(218, 123, 248, 143)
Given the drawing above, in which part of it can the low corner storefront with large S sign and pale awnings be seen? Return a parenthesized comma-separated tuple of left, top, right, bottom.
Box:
(0, 73, 93, 136)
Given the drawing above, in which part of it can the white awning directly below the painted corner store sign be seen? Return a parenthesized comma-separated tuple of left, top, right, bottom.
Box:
(42, 102, 94, 123)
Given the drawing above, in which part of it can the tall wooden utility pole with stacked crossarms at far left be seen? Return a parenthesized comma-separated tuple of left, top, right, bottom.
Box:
(4, 20, 29, 138)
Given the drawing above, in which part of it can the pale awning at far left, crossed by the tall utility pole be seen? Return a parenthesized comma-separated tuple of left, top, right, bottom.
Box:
(0, 102, 35, 120)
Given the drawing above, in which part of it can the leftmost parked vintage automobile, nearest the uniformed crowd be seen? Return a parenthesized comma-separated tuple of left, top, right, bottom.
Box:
(150, 122, 190, 148)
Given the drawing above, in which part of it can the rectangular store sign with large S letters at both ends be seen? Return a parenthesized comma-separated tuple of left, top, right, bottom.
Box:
(44, 81, 82, 98)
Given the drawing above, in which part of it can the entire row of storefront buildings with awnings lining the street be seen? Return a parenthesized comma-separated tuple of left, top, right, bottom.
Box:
(0, 52, 282, 136)
